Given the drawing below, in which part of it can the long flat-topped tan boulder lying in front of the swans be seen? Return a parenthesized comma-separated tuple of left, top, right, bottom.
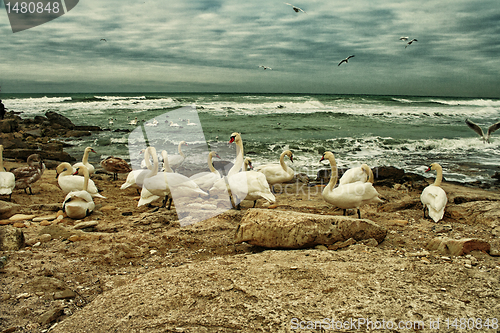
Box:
(235, 209, 387, 249)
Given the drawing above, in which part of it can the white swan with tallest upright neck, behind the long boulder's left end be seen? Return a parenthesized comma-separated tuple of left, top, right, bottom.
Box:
(219, 132, 276, 209)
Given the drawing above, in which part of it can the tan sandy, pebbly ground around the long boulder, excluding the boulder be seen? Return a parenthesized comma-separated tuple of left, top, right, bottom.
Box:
(0, 162, 500, 332)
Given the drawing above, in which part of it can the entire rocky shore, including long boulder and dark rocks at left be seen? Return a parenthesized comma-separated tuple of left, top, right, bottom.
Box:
(0, 114, 500, 333)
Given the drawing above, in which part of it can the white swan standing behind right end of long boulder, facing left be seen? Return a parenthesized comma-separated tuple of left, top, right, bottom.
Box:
(320, 151, 382, 218)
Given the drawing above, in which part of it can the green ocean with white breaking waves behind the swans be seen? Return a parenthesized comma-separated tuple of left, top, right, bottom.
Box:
(0, 93, 500, 184)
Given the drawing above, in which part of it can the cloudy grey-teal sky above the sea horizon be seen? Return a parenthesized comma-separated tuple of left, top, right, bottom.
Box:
(0, 0, 500, 98)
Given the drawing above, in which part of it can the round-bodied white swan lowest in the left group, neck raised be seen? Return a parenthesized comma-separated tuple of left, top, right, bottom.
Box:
(62, 165, 95, 219)
